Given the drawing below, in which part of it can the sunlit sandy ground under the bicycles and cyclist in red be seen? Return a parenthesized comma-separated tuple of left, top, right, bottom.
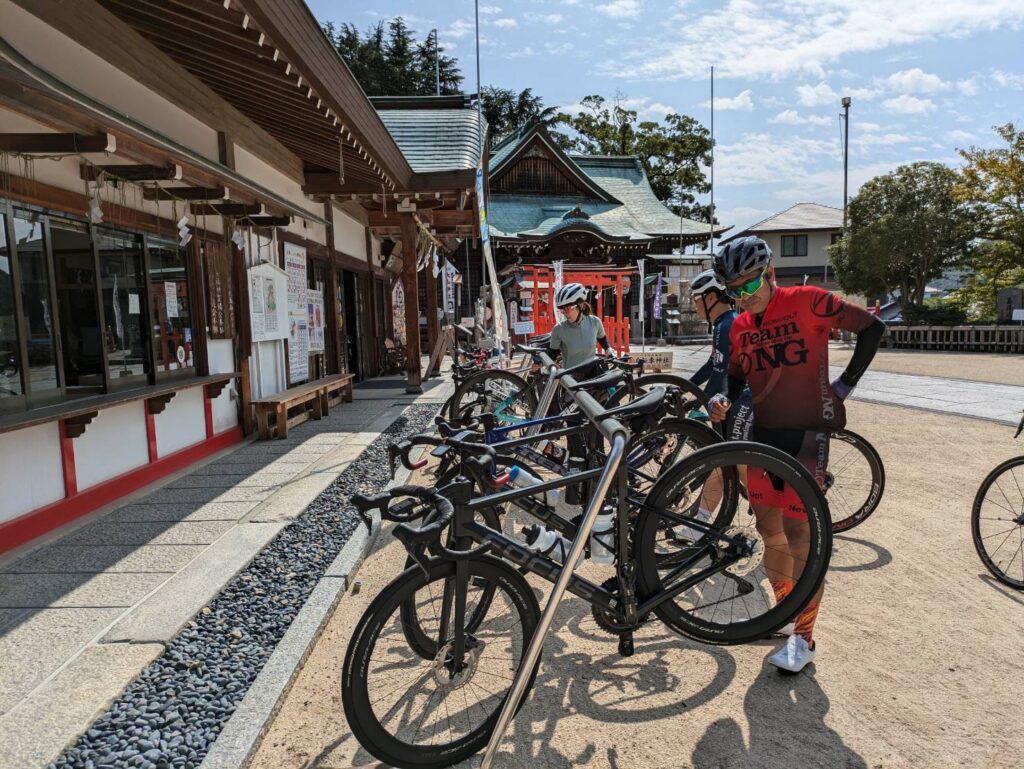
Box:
(252, 402, 1024, 769)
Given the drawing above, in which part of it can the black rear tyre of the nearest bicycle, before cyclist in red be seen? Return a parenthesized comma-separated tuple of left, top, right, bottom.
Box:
(634, 441, 831, 645)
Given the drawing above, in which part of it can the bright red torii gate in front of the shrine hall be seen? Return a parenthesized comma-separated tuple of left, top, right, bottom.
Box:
(518, 264, 635, 355)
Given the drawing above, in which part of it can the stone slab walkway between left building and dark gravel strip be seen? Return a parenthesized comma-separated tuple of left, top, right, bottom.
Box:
(0, 370, 452, 769)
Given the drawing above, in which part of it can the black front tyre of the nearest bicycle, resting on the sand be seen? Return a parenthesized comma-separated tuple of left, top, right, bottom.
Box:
(341, 555, 541, 769)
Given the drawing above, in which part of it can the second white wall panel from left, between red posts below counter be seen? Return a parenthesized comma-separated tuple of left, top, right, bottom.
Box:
(74, 400, 150, 492)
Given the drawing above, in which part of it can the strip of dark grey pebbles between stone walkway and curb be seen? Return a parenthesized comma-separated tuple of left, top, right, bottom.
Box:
(50, 404, 437, 769)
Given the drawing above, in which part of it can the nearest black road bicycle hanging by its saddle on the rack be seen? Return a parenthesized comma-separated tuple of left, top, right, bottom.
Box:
(341, 354, 831, 769)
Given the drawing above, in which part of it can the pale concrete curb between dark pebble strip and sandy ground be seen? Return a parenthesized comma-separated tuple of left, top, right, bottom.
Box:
(200, 438, 412, 769)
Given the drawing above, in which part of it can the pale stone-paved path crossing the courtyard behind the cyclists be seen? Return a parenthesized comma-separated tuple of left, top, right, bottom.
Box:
(671, 346, 1024, 425)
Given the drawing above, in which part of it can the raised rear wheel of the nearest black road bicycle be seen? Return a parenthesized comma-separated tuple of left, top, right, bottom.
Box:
(634, 441, 831, 644)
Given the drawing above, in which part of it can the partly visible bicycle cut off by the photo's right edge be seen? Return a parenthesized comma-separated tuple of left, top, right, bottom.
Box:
(971, 417, 1024, 590)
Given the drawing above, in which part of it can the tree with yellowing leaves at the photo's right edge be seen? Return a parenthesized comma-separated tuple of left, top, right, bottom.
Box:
(956, 123, 1024, 266)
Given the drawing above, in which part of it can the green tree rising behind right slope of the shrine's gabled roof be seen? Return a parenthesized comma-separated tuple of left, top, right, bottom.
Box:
(559, 94, 712, 221)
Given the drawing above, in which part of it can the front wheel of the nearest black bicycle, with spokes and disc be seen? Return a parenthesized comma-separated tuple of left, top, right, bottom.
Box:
(341, 556, 541, 769)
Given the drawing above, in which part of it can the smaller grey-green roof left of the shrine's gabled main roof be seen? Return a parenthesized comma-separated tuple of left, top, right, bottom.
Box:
(377, 108, 486, 173)
